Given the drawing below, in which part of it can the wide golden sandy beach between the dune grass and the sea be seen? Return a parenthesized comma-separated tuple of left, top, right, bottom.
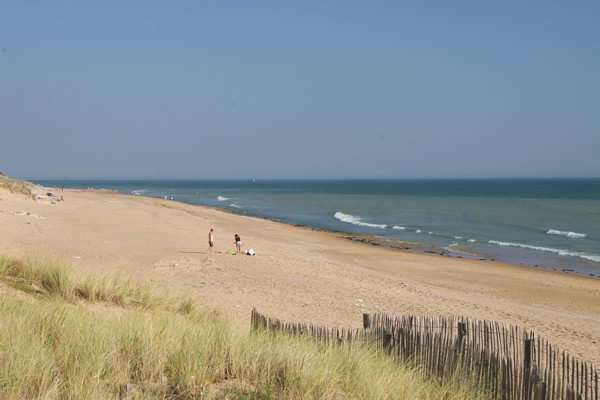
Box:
(0, 188, 600, 365)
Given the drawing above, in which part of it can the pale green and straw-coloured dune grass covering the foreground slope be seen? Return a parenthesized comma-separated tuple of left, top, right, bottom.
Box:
(0, 256, 486, 400)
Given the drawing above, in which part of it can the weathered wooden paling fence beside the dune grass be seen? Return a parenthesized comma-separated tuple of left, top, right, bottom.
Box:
(251, 310, 600, 400)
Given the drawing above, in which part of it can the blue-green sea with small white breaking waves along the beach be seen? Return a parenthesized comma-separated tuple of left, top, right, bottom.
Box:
(32, 178, 600, 277)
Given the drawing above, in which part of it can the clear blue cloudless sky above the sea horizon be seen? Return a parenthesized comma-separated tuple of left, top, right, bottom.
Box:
(0, 0, 600, 179)
